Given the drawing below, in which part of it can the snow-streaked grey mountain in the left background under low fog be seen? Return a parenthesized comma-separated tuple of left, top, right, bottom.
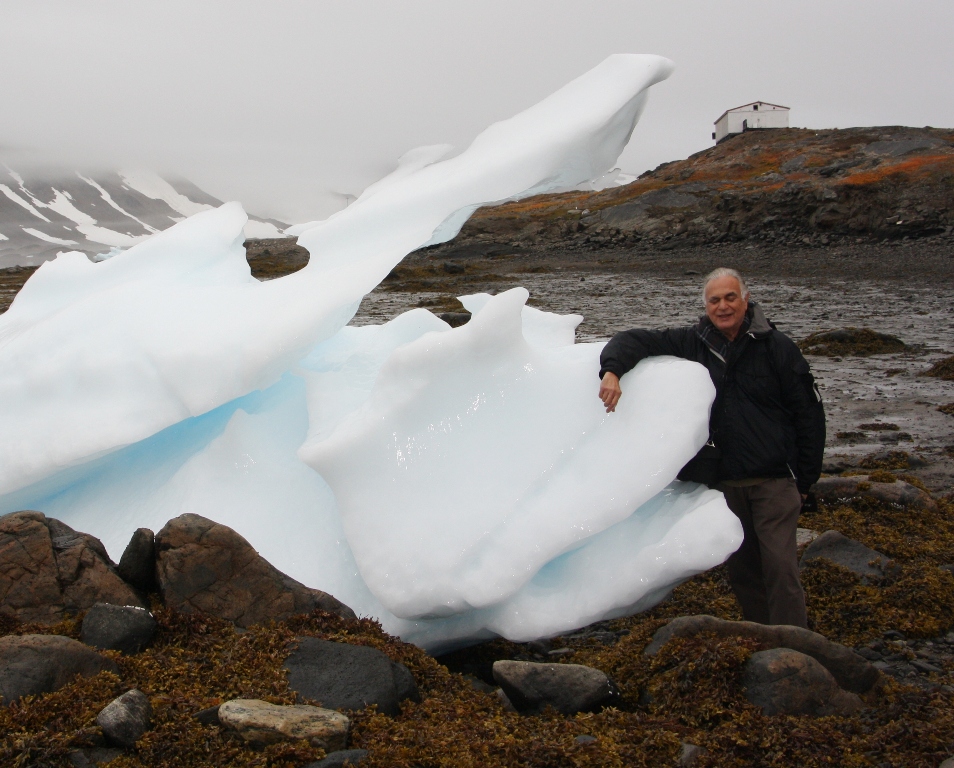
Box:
(0, 164, 288, 268)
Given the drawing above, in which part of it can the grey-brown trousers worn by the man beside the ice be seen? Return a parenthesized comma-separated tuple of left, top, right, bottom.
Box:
(718, 478, 808, 627)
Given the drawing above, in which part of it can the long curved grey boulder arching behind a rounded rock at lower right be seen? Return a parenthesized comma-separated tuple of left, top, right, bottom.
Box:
(643, 615, 881, 693)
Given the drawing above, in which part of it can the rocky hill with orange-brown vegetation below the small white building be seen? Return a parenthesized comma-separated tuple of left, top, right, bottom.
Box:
(441, 127, 954, 255)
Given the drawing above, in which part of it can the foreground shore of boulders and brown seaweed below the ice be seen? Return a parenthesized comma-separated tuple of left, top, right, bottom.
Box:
(0, 470, 954, 768)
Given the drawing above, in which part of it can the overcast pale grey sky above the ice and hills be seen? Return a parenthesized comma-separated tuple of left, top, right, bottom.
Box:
(0, 0, 954, 222)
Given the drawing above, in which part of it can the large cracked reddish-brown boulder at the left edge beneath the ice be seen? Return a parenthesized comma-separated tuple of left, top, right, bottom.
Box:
(0, 511, 145, 624)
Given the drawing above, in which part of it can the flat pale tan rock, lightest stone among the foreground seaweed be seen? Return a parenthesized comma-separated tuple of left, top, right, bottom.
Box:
(219, 699, 351, 752)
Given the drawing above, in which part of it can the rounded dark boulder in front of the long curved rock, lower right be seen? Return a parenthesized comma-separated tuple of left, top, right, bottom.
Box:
(742, 648, 863, 716)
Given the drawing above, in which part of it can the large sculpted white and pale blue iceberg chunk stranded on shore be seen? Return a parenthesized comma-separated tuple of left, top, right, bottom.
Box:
(0, 55, 741, 649)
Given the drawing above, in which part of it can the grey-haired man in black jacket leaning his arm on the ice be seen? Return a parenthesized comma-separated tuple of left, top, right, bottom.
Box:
(600, 269, 825, 627)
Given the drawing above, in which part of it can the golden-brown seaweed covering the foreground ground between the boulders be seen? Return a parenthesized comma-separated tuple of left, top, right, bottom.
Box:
(0, 486, 954, 768)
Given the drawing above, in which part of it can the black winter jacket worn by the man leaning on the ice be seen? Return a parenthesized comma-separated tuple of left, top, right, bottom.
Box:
(600, 302, 825, 493)
